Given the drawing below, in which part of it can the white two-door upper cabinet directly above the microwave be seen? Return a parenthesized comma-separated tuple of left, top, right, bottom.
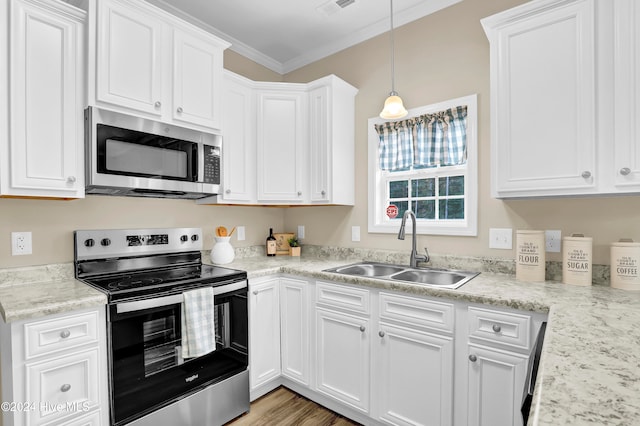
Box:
(89, 0, 229, 131)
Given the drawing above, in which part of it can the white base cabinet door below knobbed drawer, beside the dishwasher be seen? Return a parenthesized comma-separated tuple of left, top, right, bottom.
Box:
(467, 344, 529, 426)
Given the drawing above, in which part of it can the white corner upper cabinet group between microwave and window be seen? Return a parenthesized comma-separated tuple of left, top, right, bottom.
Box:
(197, 71, 357, 205)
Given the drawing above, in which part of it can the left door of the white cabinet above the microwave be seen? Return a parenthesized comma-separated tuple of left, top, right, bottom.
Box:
(96, 0, 163, 116)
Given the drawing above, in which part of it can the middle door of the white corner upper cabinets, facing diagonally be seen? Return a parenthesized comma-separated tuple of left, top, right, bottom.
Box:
(257, 89, 307, 203)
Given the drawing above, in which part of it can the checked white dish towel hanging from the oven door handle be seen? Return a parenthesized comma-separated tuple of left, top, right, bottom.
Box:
(182, 287, 216, 359)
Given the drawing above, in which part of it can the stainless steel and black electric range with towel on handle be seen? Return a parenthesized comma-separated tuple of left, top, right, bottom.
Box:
(75, 228, 249, 426)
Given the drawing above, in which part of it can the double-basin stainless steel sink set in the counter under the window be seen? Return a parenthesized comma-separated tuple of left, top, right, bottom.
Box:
(324, 262, 479, 289)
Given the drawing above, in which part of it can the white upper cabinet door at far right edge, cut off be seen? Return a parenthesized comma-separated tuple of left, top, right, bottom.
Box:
(613, 0, 640, 191)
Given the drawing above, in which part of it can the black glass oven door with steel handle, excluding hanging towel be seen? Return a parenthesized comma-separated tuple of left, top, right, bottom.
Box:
(109, 281, 248, 425)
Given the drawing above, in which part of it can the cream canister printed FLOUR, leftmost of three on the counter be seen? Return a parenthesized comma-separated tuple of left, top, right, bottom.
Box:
(516, 230, 545, 282)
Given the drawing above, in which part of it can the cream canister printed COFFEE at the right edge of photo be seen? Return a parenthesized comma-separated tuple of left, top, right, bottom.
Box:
(611, 240, 640, 291)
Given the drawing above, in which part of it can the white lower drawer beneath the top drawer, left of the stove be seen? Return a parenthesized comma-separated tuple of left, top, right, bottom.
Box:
(25, 348, 100, 425)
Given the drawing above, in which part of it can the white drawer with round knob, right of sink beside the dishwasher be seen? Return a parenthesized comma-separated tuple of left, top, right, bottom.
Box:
(468, 307, 531, 350)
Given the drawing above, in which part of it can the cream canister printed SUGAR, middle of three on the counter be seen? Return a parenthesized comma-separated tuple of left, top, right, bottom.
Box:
(562, 234, 593, 286)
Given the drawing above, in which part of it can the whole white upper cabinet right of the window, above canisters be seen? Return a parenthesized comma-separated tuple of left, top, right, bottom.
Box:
(482, 0, 640, 198)
